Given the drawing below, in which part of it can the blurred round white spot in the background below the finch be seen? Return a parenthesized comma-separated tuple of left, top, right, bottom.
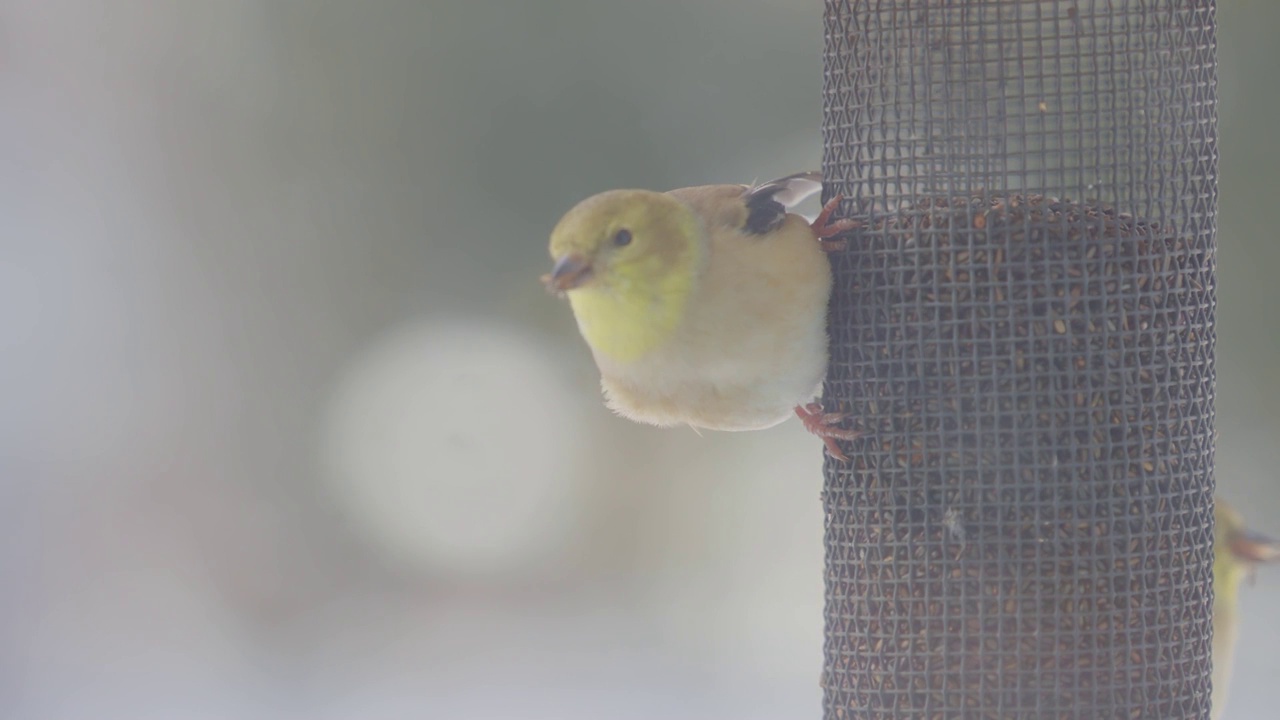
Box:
(323, 320, 590, 578)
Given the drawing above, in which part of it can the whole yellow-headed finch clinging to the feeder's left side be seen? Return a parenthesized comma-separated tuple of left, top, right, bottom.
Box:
(543, 173, 860, 460)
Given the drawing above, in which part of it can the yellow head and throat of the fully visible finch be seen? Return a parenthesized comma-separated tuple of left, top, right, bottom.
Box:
(543, 190, 707, 363)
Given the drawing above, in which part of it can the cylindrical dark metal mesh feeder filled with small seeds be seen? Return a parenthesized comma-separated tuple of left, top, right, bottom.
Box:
(823, 0, 1217, 720)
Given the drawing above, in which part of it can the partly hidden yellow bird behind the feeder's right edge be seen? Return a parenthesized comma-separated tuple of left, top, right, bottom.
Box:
(1210, 498, 1280, 720)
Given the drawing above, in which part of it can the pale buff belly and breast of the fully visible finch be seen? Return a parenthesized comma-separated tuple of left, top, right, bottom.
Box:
(596, 218, 831, 430)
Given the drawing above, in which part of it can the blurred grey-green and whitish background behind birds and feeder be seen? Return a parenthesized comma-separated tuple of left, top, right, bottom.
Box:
(0, 0, 1280, 720)
